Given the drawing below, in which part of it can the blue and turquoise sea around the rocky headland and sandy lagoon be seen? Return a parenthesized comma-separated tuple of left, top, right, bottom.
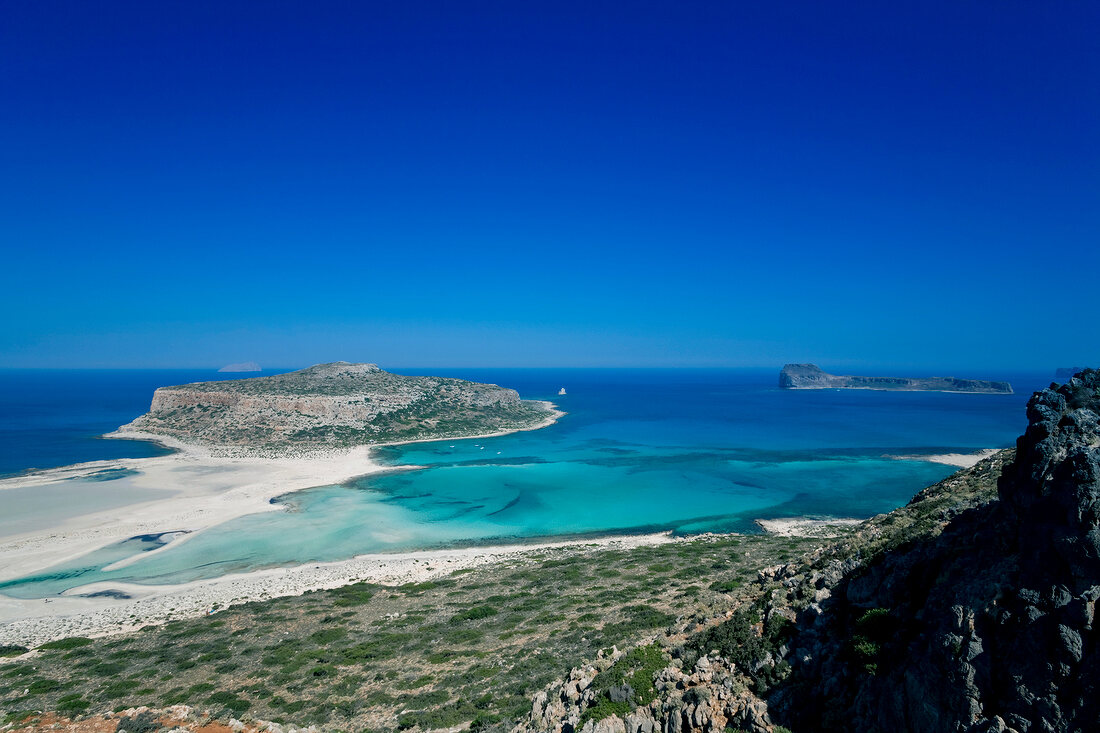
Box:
(0, 369, 1051, 598)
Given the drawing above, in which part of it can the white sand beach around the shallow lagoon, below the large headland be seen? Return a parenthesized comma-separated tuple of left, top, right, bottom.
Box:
(0, 411, 572, 645)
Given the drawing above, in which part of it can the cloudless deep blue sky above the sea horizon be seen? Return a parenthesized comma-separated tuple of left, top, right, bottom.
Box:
(0, 0, 1100, 371)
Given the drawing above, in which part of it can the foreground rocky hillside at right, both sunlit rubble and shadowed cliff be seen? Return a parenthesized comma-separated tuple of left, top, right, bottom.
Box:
(520, 370, 1100, 733)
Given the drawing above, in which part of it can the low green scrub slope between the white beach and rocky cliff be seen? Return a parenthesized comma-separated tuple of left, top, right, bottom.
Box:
(0, 536, 827, 732)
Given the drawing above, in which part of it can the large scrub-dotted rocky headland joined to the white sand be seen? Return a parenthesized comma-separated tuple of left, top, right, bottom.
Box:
(118, 361, 559, 449)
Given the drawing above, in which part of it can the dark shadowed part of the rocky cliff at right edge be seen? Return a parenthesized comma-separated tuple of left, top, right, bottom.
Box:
(771, 371, 1100, 733)
